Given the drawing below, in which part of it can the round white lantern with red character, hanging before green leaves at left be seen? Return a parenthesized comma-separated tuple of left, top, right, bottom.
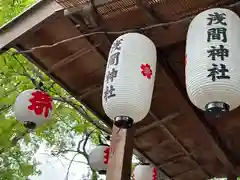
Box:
(14, 89, 53, 129)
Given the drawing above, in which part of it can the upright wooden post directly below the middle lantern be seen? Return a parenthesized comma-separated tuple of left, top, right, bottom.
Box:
(107, 125, 135, 180)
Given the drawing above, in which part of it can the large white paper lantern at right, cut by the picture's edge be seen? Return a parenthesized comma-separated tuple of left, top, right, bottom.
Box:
(185, 8, 240, 117)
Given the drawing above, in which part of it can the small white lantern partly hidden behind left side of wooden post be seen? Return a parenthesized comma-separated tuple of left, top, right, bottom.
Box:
(89, 145, 110, 174)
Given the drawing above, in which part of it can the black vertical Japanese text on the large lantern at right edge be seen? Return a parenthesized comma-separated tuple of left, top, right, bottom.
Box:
(207, 12, 230, 82)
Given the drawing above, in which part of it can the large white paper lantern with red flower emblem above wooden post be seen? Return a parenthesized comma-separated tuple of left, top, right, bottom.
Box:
(102, 33, 157, 128)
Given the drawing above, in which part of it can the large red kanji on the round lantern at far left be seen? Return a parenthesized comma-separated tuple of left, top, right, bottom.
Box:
(28, 91, 52, 118)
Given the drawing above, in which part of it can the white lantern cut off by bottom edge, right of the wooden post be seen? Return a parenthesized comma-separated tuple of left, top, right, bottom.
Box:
(133, 164, 158, 180)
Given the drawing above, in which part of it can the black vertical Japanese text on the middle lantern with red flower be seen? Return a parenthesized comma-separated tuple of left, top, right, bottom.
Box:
(104, 39, 123, 101)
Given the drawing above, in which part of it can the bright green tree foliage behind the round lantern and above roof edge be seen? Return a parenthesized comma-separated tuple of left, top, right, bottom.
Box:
(0, 0, 107, 180)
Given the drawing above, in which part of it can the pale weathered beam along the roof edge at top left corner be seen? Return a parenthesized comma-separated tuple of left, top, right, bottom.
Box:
(0, 0, 63, 49)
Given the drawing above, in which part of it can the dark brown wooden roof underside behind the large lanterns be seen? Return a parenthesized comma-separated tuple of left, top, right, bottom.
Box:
(0, 0, 240, 180)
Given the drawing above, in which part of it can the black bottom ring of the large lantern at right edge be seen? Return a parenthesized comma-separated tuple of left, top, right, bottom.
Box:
(205, 102, 230, 118)
